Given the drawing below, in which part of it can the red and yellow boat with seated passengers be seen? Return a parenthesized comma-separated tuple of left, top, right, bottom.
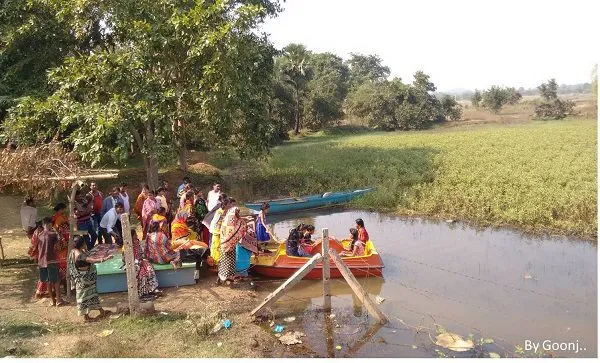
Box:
(251, 238, 383, 280)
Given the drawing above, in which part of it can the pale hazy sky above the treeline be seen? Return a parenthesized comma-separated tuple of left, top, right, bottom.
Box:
(262, 0, 600, 91)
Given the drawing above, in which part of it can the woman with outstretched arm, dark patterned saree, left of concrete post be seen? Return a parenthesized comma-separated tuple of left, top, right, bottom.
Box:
(69, 236, 112, 323)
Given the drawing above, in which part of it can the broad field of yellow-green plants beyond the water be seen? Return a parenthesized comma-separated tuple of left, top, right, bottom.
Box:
(218, 120, 597, 238)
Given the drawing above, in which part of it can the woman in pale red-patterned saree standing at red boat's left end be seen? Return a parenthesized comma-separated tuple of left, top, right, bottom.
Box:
(217, 207, 246, 284)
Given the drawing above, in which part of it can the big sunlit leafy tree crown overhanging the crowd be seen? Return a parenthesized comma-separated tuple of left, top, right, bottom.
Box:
(4, 0, 279, 191)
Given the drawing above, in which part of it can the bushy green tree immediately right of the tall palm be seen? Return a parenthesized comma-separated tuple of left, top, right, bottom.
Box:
(303, 53, 349, 130)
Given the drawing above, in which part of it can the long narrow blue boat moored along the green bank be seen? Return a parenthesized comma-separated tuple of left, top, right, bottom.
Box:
(245, 188, 373, 214)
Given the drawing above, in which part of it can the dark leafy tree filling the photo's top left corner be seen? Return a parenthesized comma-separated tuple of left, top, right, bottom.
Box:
(0, 0, 110, 123)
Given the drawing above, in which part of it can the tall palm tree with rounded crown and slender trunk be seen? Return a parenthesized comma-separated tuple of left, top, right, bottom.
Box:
(277, 44, 310, 135)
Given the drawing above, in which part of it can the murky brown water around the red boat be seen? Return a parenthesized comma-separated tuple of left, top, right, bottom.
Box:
(255, 209, 597, 357)
